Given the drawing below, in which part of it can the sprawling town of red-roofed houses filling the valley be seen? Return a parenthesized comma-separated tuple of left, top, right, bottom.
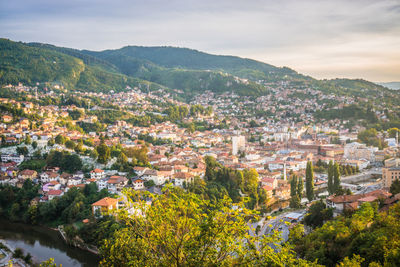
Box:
(0, 81, 400, 267)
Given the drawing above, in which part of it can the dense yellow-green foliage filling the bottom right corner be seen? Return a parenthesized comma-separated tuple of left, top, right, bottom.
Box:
(295, 203, 400, 266)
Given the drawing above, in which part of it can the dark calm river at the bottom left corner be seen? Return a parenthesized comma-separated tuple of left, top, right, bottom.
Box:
(0, 220, 99, 267)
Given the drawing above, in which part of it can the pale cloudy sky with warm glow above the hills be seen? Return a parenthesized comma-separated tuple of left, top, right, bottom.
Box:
(0, 0, 400, 82)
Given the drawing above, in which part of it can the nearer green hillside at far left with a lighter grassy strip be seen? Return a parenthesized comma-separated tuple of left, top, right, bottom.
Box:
(0, 39, 160, 91)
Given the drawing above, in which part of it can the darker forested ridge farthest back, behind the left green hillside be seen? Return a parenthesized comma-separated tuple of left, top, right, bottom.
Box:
(82, 46, 307, 80)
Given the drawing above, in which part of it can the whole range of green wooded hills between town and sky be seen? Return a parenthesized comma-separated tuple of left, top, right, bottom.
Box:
(0, 39, 394, 99)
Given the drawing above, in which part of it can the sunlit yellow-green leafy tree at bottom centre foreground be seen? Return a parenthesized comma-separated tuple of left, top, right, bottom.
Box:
(101, 187, 317, 266)
